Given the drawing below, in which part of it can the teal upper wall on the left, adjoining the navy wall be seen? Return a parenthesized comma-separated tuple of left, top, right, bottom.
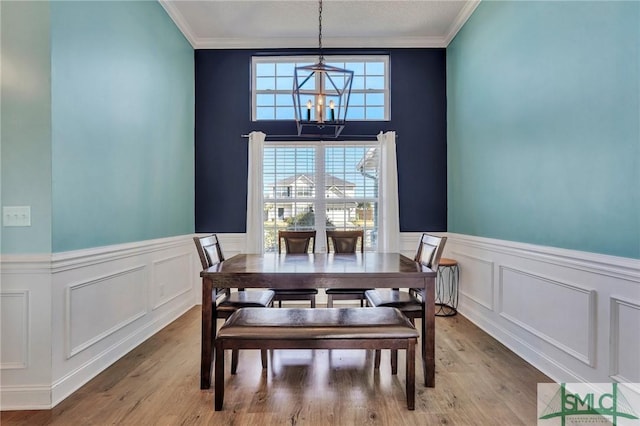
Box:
(51, 1, 194, 252)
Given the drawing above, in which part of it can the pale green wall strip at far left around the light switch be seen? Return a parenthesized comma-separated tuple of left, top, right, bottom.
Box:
(0, 1, 51, 253)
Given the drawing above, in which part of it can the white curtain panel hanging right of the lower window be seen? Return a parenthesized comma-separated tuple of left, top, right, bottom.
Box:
(378, 131, 400, 253)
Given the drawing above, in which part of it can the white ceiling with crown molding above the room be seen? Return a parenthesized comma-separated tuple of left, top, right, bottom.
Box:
(159, 0, 480, 49)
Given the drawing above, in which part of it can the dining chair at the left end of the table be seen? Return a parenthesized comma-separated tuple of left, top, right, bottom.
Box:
(193, 234, 275, 374)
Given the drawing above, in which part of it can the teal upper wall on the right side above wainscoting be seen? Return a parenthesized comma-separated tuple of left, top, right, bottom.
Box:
(447, 1, 640, 258)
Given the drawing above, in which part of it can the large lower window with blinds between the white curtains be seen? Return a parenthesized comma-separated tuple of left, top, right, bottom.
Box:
(263, 142, 379, 252)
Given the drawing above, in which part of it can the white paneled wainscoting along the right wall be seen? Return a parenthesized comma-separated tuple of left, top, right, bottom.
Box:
(444, 234, 640, 383)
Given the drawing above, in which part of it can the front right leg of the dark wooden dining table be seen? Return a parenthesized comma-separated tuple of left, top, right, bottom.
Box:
(421, 277, 436, 388)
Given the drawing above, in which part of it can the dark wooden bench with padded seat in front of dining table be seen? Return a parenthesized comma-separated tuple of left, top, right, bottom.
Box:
(215, 307, 418, 411)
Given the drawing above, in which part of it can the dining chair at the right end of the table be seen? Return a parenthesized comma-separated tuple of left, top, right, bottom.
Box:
(365, 233, 447, 371)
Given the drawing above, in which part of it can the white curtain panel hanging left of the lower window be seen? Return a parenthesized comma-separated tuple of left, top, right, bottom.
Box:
(245, 132, 267, 253)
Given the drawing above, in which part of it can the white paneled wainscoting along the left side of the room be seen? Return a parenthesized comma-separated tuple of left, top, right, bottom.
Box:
(0, 235, 201, 410)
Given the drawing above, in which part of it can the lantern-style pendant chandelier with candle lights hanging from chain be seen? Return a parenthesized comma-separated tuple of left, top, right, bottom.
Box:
(293, 0, 353, 138)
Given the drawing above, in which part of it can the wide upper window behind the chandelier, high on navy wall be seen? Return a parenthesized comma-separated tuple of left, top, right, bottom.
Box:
(251, 56, 390, 121)
